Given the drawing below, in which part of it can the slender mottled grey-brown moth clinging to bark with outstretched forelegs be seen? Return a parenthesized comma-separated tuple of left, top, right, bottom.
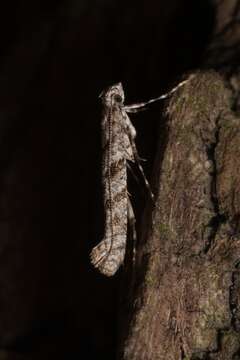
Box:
(90, 78, 193, 276)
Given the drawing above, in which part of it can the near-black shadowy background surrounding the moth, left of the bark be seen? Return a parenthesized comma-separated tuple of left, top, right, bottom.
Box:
(0, 0, 214, 360)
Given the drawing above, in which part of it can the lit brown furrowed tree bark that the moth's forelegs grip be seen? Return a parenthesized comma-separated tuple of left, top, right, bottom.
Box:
(123, 72, 240, 360)
